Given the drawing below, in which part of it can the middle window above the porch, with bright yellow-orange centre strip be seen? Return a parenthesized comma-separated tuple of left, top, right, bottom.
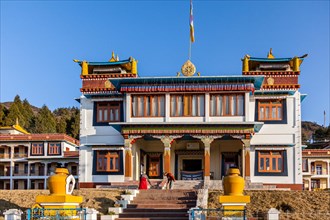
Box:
(171, 95, 205, 117)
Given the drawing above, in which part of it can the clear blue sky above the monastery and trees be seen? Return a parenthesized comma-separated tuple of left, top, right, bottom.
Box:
(0, 0, 330, 124)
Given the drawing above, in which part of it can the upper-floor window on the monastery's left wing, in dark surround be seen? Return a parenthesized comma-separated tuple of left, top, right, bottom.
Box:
(96, 102, 120, 123)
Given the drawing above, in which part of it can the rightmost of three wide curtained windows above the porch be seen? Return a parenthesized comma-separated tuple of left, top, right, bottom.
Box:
(210, 94, 244, 116)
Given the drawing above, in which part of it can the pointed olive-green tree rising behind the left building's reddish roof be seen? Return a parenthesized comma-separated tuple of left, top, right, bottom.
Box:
(34, 105, 56, 133)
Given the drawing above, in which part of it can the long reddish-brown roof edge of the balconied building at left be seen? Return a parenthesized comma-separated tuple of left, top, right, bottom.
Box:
(0, 134, 79, 145)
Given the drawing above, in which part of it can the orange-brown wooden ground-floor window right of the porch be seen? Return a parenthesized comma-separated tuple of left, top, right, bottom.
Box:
(258, 151, 283, 173)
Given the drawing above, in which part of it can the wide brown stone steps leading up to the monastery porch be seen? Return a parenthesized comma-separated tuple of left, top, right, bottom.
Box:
(117, 189, 197, 220)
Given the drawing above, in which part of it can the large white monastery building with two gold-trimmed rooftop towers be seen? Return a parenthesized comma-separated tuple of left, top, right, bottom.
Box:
(75, 52, 305, 189)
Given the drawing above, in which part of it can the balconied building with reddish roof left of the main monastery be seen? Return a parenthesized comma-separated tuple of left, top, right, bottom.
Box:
(0, 124, 79, 190)
